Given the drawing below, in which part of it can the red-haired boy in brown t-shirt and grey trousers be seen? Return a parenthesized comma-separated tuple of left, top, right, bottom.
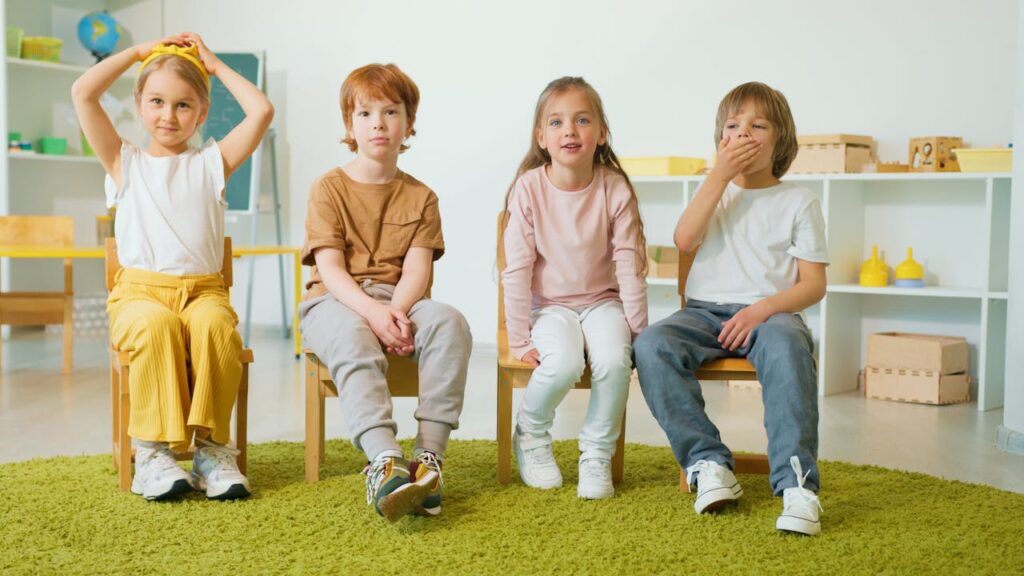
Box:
(299, 64, 472, 522)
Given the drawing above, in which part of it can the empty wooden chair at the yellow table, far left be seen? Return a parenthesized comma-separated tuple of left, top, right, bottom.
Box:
(0, 216, 75, 374)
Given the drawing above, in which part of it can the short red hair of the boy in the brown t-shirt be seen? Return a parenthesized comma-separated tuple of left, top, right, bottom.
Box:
(340, 64, 420, 153)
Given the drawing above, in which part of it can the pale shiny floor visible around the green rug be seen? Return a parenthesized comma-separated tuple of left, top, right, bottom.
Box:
(6, 330, 1024, 493)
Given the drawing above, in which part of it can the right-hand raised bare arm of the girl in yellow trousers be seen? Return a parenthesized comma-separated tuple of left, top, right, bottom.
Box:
(182, 32, 273, 179)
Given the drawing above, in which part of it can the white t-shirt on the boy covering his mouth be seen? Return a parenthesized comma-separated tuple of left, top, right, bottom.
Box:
(686, 182, 828, 304)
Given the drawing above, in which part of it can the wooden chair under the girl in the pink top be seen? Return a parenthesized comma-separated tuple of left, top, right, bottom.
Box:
(498, 212, 626, 484)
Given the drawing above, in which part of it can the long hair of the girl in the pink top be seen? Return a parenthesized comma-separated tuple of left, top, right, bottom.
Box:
(499, 76, 647, 278)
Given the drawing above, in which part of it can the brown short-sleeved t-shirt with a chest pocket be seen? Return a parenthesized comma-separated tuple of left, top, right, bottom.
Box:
(302, 168, 444, 299)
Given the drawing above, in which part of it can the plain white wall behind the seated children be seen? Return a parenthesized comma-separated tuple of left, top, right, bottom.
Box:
(165, 0, 1018, 341)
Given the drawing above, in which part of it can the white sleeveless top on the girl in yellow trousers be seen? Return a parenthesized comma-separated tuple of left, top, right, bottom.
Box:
(104, 138, 227, 276)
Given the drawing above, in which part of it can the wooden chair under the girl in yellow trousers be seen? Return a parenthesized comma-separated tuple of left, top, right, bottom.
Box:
(105, 238, 253, 491)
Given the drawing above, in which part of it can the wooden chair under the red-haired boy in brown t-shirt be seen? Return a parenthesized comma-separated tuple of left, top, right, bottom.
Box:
(296, 270, 434, 484)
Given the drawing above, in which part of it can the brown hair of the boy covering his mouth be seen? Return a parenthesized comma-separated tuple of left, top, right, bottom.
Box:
(715, 82, 798, 178)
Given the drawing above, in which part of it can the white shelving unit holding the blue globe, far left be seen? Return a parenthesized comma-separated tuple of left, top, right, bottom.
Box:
(0, 0, 163, 292)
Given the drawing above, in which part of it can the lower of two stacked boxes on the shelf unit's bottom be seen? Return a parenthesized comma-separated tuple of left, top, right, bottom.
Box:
(864, 366, 971, 404)
